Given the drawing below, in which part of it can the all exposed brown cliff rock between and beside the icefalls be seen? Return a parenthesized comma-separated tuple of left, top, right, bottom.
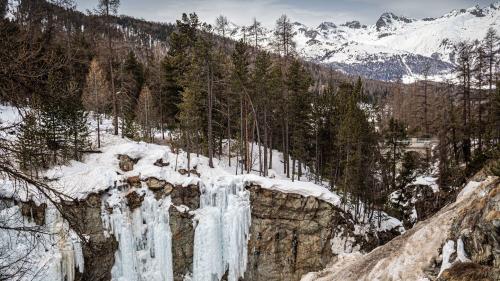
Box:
(55, 178, 398, 281)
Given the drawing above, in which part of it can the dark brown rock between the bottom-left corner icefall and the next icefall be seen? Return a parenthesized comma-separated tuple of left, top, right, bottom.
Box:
(64, 194, 118, 281)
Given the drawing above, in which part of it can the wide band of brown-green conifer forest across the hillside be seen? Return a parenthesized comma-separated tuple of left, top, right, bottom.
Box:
(0, 0, 499, 222)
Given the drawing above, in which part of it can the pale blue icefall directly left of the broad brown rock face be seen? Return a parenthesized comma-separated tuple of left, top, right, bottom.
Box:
(192, 178, 251, 281)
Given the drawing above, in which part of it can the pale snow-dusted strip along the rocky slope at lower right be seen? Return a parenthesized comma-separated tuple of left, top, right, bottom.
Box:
(302, 177, 495, 281)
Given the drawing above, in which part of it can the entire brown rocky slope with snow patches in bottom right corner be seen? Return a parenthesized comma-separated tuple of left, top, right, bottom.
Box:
(302, 176, 500, 281)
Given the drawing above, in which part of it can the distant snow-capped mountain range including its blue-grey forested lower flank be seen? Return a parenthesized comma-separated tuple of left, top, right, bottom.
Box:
(230, 1, 500, 80)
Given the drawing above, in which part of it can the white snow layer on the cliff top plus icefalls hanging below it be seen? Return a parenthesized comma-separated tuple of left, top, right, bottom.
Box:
(0, 107, 404, 281)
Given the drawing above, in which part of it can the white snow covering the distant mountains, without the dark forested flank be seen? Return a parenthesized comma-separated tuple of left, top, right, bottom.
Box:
(226, 2, 500, 80)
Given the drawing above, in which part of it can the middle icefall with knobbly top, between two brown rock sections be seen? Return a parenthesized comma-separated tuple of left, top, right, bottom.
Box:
(103, 189, 173, 281)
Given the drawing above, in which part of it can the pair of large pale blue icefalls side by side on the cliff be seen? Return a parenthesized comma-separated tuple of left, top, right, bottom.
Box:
(102, 179, 251, 281)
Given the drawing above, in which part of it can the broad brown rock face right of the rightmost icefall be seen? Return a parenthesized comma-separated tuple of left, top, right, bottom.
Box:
(245, 186, 378, 281)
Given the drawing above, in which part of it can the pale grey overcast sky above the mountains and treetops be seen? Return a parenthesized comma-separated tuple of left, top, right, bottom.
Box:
(76, 0, 494, 27)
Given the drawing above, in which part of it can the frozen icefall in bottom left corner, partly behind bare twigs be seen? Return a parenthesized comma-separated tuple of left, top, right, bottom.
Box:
(0, 201, 84, 281)
